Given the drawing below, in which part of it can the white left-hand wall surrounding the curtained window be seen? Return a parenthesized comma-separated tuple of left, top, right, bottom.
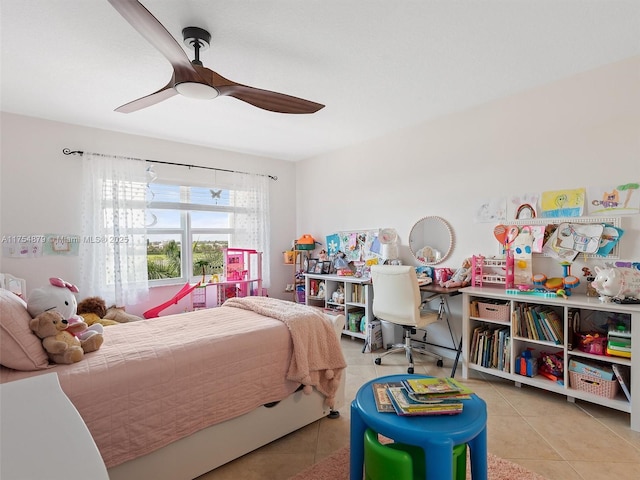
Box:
(0, 113, 296, 314)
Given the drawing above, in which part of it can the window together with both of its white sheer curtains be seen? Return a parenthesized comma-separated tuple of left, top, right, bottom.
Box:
(80, 153, 270, 305)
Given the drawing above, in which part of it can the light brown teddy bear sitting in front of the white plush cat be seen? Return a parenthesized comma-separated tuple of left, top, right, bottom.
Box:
(29, 310, 103, 363)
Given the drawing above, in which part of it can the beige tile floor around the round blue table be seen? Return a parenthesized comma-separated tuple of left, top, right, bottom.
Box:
(199, 337, 640, 480)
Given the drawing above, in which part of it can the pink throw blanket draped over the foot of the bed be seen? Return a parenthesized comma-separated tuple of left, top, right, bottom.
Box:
(224, 297, 347, 406)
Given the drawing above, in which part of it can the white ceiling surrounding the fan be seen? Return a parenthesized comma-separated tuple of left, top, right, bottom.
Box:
(0, 0, 640, 161)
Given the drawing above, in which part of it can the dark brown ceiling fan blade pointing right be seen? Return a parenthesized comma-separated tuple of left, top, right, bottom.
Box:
(194, 65, 324, 113)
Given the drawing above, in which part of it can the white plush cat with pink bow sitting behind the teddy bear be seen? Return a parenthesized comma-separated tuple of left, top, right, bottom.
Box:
(27, 278, 104, 353)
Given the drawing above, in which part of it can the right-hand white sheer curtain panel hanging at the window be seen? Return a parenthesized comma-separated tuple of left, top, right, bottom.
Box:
(229, 174, 271, 288)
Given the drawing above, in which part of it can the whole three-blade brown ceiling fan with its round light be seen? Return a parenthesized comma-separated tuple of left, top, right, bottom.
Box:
(109, 0, 324, 113)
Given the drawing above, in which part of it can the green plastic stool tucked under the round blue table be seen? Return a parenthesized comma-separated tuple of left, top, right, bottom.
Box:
(364, 428, 467, 480)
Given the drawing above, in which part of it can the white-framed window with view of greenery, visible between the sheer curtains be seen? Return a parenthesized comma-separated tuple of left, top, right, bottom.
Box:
(147, 183, 231, 284)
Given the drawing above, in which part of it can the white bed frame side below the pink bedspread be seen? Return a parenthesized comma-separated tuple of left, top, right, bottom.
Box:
(109, 315, 347, 480)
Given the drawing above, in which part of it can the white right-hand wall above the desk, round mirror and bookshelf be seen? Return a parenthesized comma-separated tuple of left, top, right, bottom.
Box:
(297, 57, 640, 356)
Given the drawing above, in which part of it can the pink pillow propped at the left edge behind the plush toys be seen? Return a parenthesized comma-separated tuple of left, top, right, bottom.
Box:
(0, 288, 49, 371)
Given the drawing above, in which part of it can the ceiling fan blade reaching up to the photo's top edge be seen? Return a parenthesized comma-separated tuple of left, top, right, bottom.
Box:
(109, 0, 202, 82)
